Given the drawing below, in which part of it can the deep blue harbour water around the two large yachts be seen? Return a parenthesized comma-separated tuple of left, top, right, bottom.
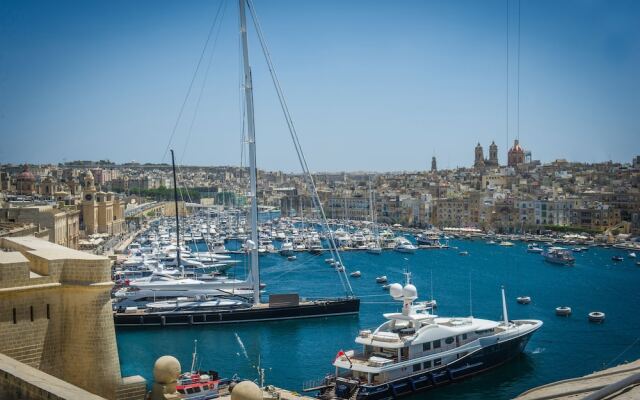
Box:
(117, 240, 640, 399)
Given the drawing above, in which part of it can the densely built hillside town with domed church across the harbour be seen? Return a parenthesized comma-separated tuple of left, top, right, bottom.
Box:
(0, 140, 640, 249)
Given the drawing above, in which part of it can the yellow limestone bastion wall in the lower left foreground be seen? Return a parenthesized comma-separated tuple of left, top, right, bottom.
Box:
(0, 236, 145, 400)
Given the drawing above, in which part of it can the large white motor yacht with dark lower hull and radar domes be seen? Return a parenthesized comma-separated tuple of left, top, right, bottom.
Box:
(306, 274, 542, 400)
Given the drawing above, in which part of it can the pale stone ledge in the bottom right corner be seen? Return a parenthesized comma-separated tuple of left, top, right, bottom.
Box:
(516, 360, 640, 400)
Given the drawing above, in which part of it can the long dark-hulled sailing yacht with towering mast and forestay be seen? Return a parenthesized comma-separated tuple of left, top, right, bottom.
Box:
(114, 0, 360, 326)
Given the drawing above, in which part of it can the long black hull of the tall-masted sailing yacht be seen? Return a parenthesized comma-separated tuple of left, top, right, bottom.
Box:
(113, 299, 360, 326)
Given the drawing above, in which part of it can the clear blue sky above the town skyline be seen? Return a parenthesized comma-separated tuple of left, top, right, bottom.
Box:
(0, 0, 640, 171)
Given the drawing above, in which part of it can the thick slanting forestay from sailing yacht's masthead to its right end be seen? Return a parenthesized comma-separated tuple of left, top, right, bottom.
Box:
(247, 0, 353, 296)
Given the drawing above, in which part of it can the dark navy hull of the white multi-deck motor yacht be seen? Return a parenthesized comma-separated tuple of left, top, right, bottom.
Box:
(328, 332, 533, 400)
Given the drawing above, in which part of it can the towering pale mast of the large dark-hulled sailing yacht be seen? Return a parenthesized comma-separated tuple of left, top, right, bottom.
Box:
(239, 0, 260, 304)
